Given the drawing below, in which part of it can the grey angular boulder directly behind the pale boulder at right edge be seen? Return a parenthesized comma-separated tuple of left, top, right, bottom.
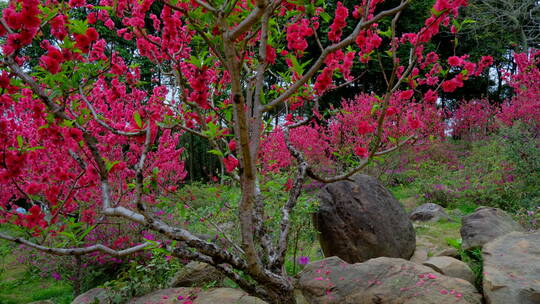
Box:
(460, 207, 523, 250)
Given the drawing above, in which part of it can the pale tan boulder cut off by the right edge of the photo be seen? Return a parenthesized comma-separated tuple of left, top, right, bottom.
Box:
(482, 231, 540, 304)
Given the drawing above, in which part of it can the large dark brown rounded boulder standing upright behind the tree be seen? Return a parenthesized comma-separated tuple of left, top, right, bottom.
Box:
(314, 175, 416, 263)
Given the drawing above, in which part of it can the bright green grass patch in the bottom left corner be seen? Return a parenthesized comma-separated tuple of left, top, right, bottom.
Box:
(0, 241, 73, 304)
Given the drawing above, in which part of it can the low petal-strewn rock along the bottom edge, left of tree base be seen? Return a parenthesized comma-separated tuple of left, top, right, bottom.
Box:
(128, 287, 266, 304)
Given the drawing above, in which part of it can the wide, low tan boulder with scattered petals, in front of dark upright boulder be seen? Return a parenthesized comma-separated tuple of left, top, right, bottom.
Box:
(298, 257, 482, 304)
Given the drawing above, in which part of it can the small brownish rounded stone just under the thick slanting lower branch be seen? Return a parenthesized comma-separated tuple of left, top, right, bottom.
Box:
(170, 261, 224, 287)
